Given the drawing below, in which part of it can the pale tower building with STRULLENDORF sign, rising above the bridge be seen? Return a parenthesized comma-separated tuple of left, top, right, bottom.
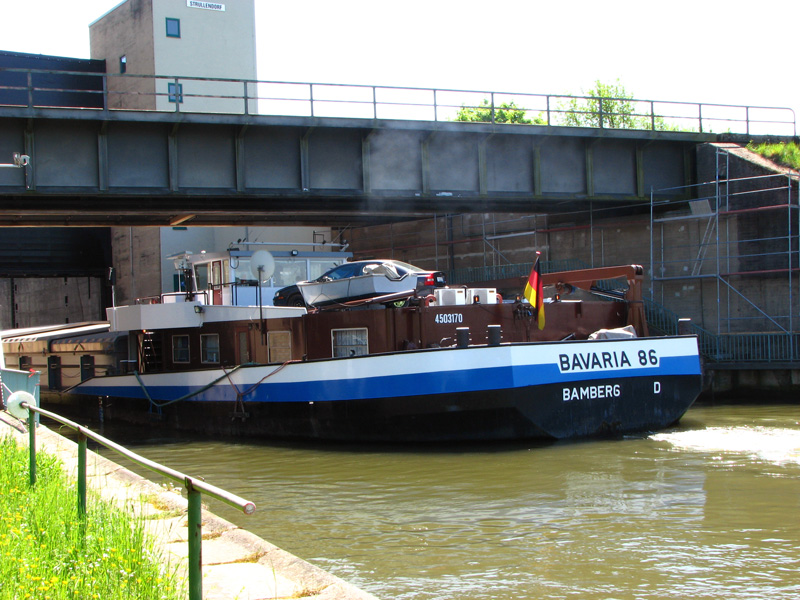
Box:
(89, 0, 256, 113)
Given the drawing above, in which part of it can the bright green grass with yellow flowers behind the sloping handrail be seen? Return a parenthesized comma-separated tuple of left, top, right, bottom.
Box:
(0, 437, 185, 600)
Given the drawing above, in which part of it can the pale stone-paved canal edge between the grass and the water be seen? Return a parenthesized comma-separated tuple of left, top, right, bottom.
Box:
(0, 411, 376, 600)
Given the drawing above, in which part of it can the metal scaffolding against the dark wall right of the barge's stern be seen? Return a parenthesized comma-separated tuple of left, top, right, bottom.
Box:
(650, 148, 800, 362)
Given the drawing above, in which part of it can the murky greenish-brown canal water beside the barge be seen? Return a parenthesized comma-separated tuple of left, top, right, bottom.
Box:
(81, 405, 800, 600)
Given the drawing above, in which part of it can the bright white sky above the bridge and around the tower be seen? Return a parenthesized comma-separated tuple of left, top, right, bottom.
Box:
(0, 0, 800, 132)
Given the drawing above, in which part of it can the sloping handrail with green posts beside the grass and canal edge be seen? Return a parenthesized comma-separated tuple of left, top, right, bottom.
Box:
(19, 396, 256, 600)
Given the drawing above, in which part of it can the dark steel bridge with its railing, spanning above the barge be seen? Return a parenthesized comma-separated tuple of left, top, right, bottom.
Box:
(0, 69, 796, 227)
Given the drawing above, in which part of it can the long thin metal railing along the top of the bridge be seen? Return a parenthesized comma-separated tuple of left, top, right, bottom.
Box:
(0, 67, 797, 136)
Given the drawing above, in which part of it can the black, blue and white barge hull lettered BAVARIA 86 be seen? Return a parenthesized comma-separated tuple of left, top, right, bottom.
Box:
(73, 337, 701, 442)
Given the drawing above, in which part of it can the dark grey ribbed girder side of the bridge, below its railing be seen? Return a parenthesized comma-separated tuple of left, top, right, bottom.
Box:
(0, 109, 707, 226)
